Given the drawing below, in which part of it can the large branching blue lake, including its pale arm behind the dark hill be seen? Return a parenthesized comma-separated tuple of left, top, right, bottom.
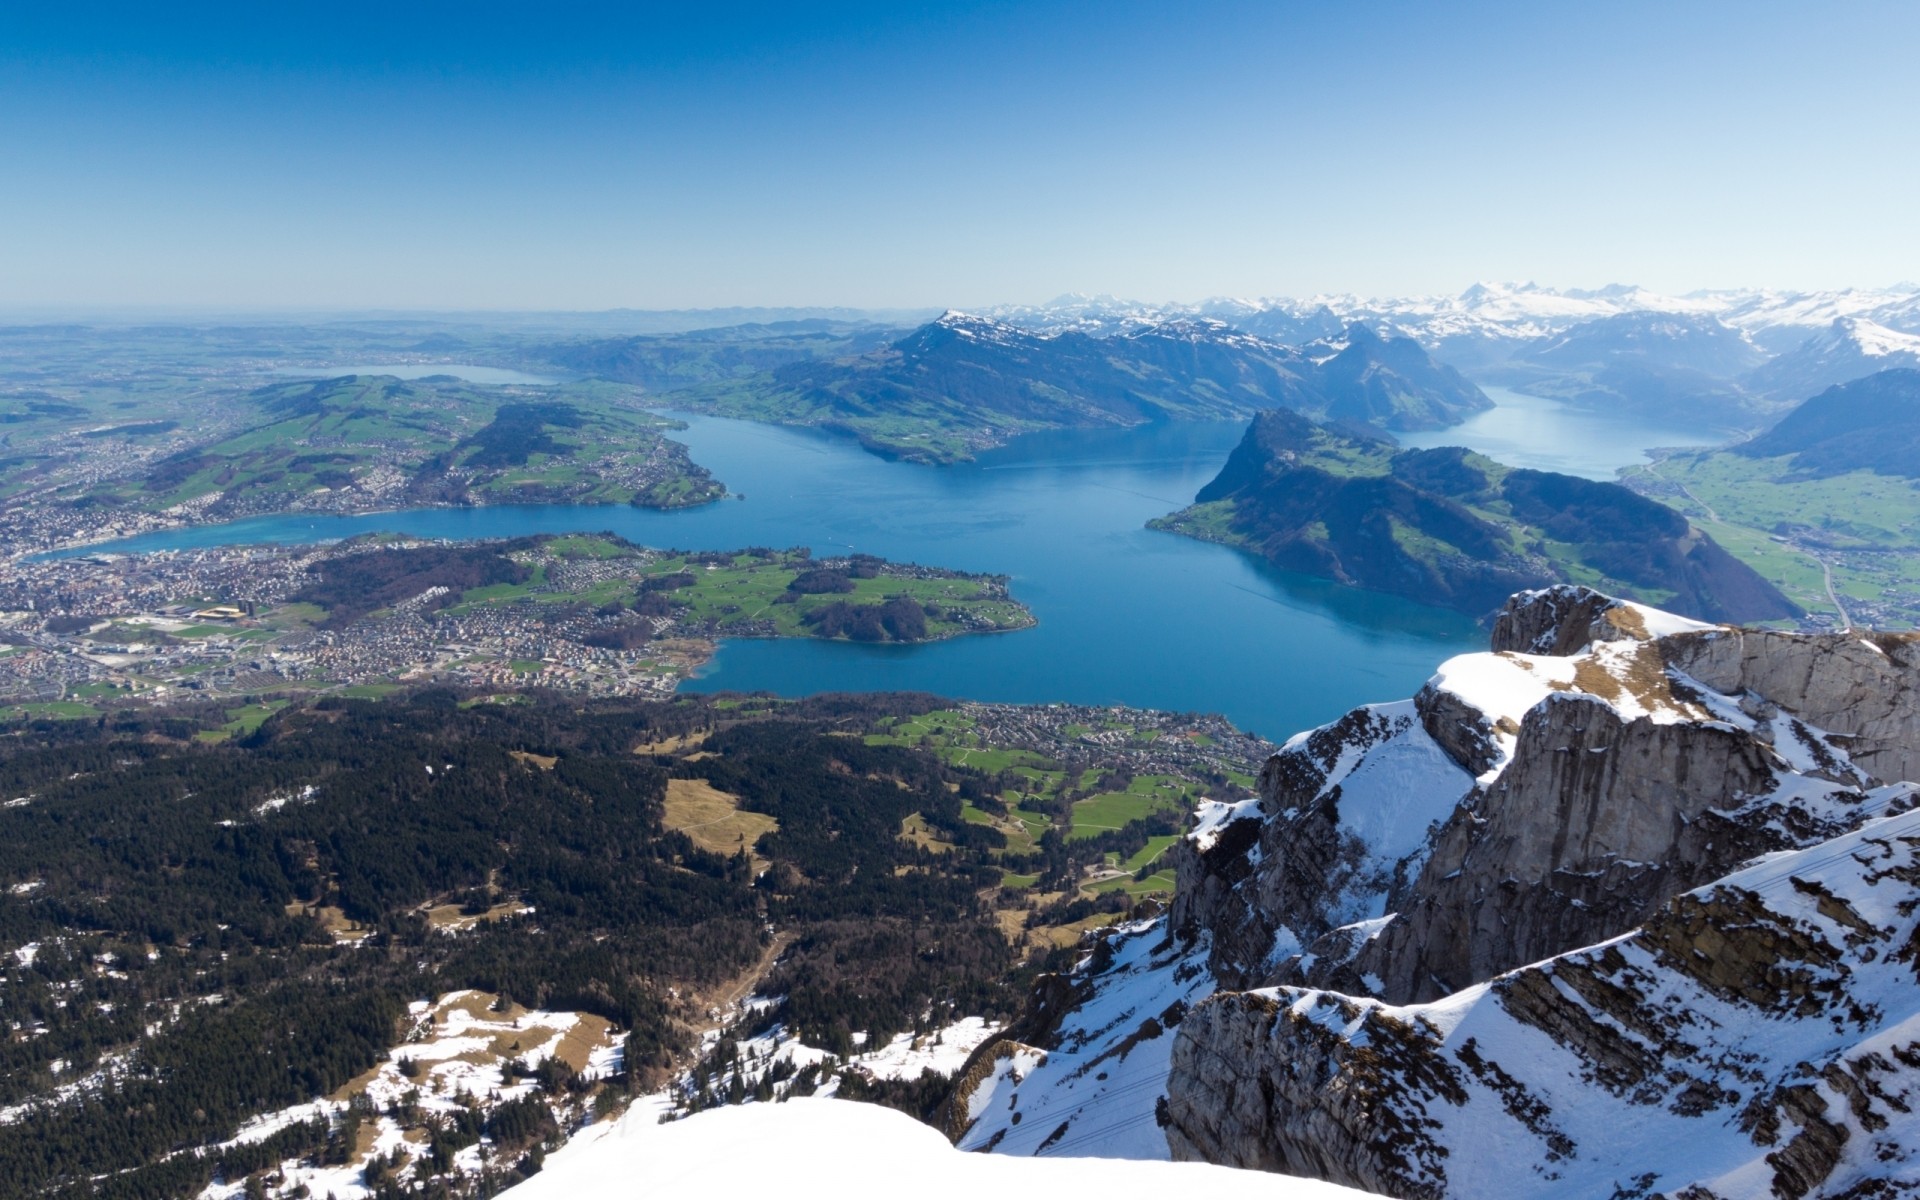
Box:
(71, 387, 1712, 737)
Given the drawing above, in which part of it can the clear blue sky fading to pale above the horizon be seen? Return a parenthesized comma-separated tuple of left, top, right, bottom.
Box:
(0, 0, 1920, 309)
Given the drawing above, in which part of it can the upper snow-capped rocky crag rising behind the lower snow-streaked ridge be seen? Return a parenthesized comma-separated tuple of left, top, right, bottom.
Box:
(1175, 588, 1920, 1002)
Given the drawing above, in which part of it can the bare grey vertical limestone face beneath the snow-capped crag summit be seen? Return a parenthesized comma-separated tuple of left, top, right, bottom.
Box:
(1354, 693, 1820, 1002)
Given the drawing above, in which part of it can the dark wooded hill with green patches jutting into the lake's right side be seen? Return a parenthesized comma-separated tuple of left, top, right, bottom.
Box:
(1154, 411, 1799, 620)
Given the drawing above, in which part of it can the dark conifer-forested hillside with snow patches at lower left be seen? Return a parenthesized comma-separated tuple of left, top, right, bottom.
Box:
(0, 691, 1044, 1196)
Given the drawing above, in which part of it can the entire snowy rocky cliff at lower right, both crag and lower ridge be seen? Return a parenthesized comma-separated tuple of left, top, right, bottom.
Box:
(950, 588, 1920, 1200)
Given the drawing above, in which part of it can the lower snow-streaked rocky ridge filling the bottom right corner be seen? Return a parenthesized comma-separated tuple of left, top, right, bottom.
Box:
(1165, 806, 1920, 1200)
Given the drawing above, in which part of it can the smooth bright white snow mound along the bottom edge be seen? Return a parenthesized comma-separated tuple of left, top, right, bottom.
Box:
(505, 1098, 1365, 1200)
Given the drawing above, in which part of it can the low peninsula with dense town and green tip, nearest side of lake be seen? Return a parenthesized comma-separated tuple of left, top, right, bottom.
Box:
(0, 534, 1035, 706)
